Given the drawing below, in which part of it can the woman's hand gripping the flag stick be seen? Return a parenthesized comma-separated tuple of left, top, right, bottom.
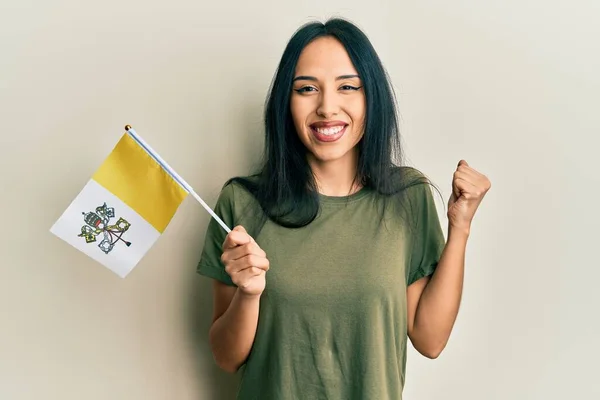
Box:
(221, 226, 269, 296)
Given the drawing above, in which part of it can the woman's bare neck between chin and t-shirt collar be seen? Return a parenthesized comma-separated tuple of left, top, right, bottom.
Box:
(309, 149, 362, 196)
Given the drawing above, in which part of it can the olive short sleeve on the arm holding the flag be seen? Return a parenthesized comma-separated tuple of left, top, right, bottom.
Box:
(196, 184, 235, 286)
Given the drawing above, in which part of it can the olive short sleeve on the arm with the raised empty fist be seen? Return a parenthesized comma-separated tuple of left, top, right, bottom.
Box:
(407, 184, 446, 286)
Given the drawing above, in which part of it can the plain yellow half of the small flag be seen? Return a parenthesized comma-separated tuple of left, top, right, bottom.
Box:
(92, 133, 187, 233)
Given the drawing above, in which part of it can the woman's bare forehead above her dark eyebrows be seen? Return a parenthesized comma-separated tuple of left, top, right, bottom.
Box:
(296, 37, 357, 77)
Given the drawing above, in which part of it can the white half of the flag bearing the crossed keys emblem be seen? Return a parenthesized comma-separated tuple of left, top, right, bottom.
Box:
(51, 179, 160, 278)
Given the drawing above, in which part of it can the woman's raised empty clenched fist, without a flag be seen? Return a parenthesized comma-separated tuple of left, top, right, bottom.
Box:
(448, 160, 492, 233)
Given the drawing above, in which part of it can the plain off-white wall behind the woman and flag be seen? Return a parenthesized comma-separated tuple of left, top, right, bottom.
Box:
(0, 0, 600, 400)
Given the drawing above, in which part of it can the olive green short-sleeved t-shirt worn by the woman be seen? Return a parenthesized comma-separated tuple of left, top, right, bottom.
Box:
(198, 170, 445, 400)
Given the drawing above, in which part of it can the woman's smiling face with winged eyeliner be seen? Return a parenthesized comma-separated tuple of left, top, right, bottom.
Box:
(291, 37, 366, 167)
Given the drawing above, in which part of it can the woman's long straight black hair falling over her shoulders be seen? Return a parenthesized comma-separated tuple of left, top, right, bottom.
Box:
(227, 18, 438, 234)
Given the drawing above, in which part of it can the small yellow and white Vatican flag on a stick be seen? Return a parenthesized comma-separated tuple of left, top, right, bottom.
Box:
(50, 126, 228, 278)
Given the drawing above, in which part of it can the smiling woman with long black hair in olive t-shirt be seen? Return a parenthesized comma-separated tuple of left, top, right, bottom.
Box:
(198, 19, 490, 400)
